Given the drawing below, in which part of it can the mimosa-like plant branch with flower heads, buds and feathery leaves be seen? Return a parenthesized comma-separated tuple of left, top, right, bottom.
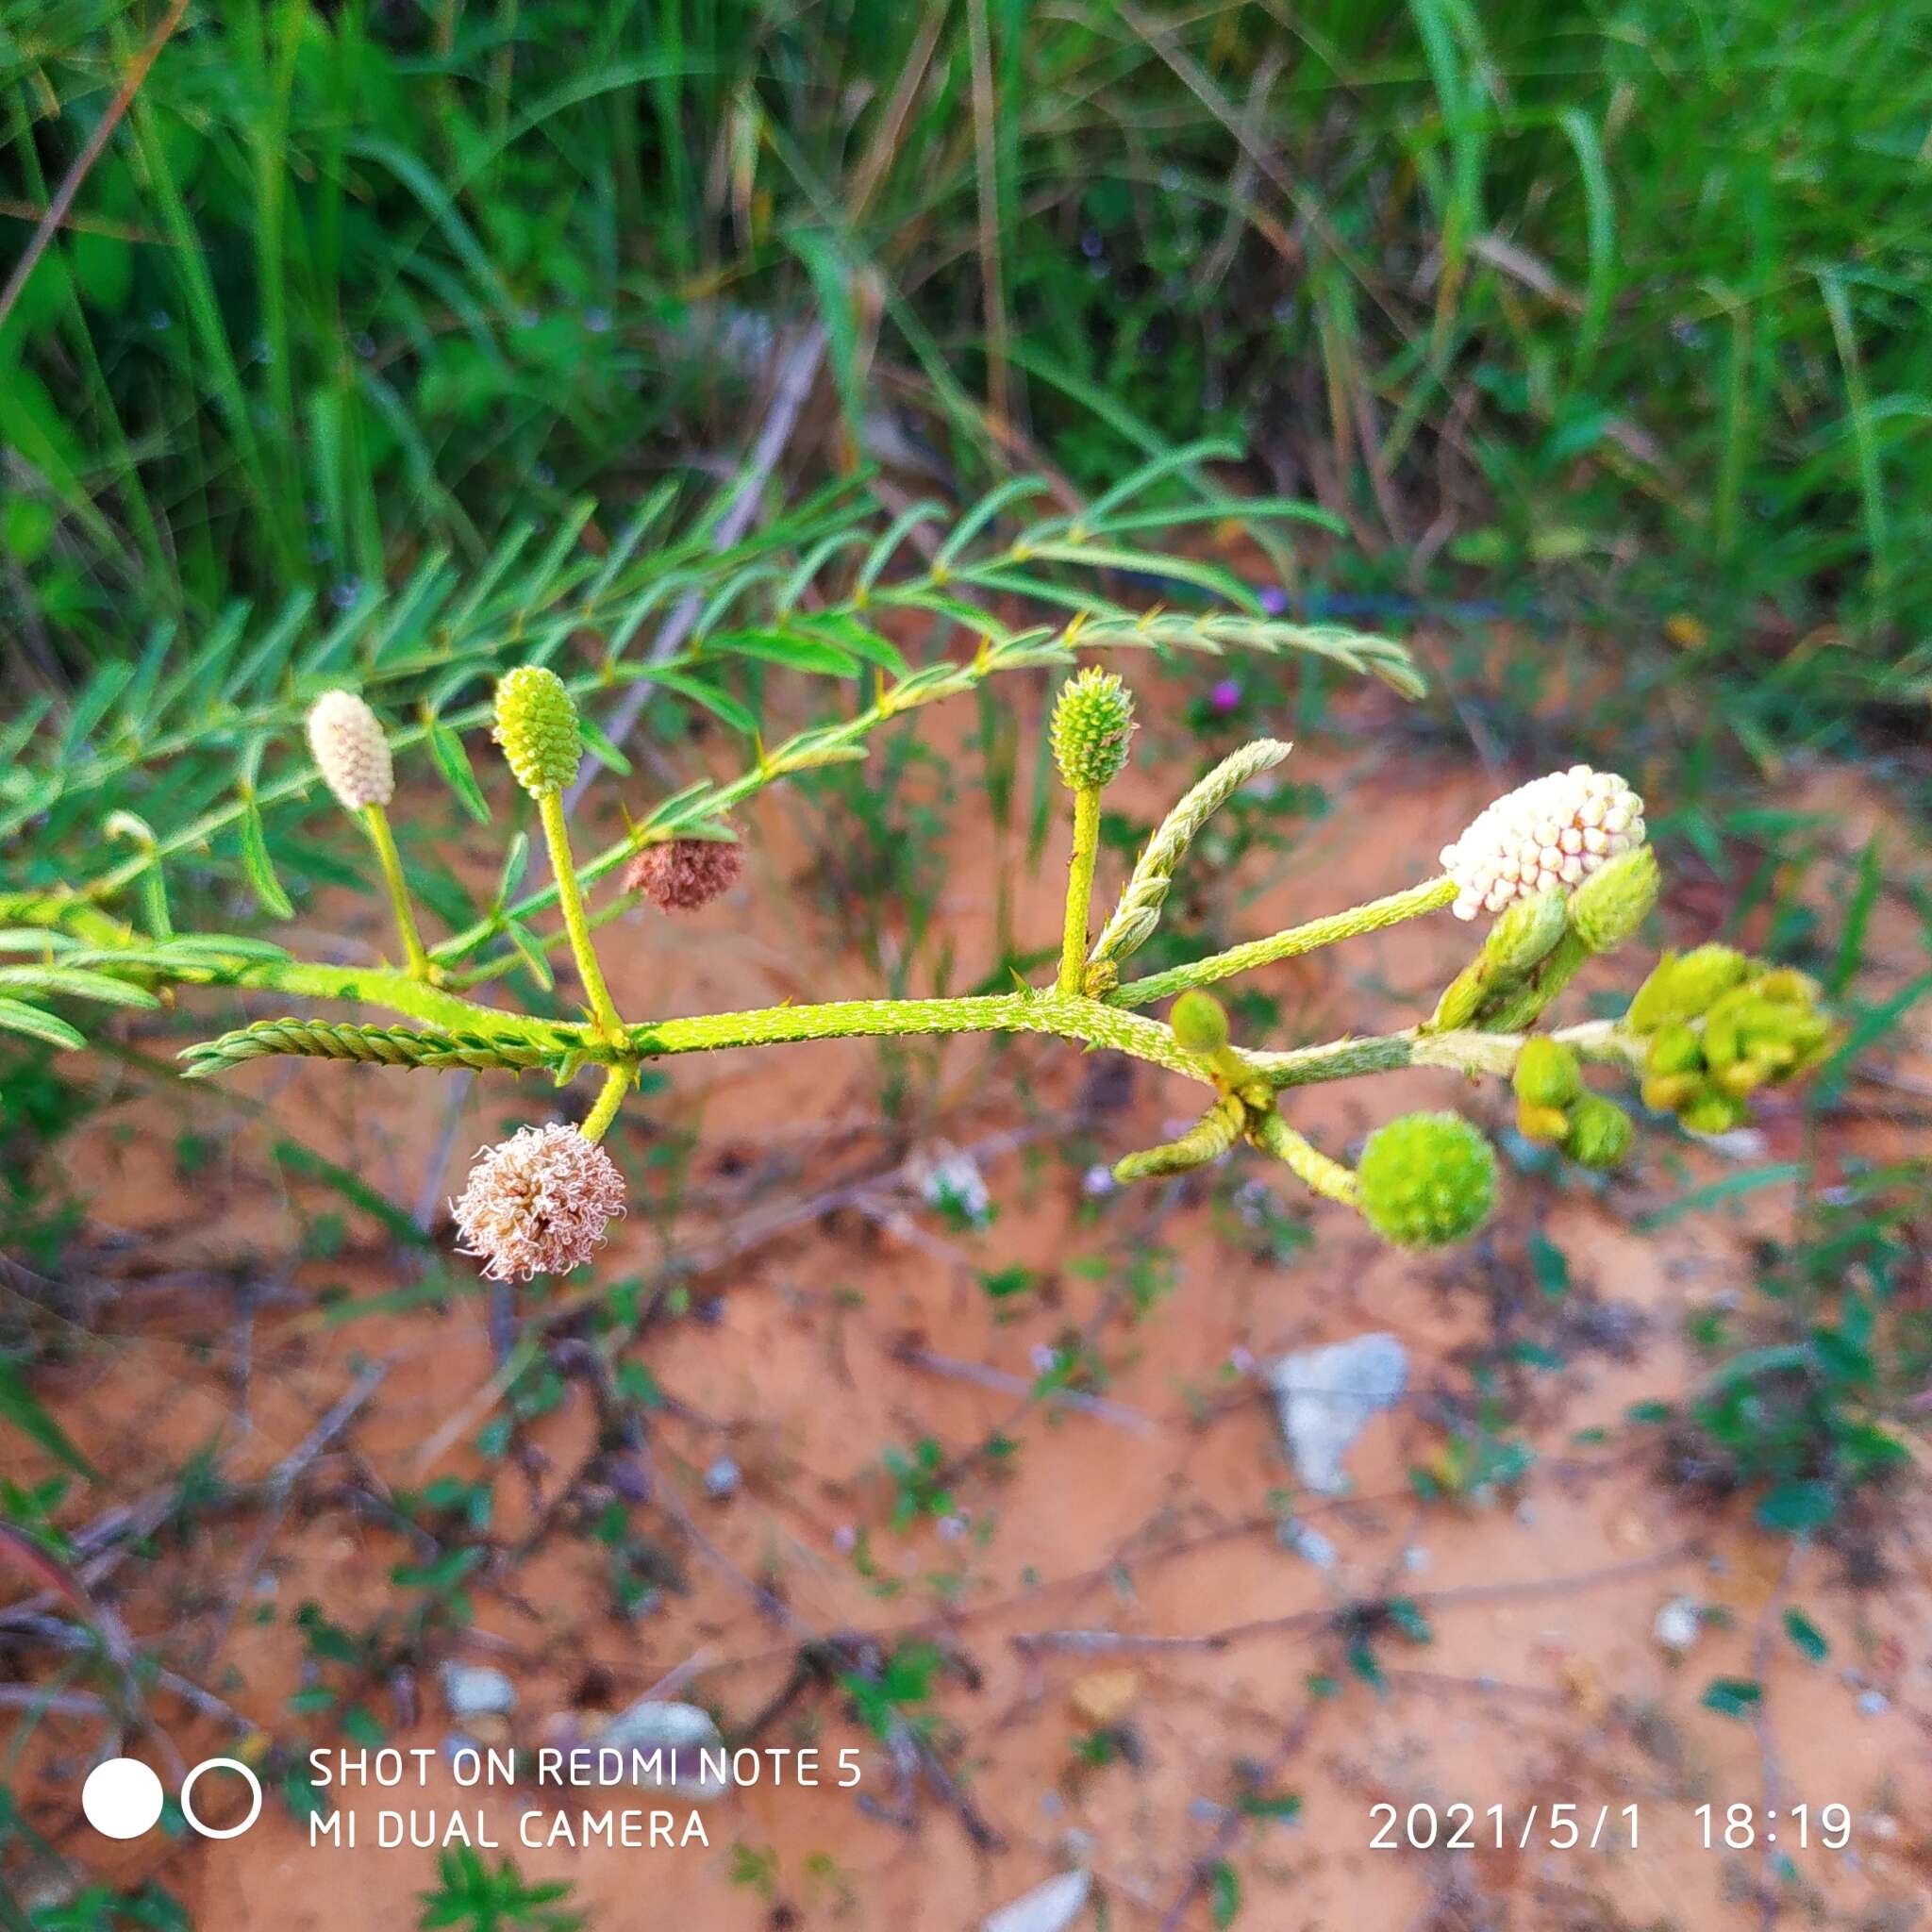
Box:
(0, 465, 1834, 1279)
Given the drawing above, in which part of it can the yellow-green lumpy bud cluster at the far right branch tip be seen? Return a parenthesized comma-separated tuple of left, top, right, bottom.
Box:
(1624, 947, 1838, 1134)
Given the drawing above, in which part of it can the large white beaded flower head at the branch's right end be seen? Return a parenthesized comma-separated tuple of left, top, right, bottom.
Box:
(1443, 765, 1644, 920)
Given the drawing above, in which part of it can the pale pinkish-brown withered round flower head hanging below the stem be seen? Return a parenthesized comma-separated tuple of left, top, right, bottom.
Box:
(450, 1121, 625, 1281)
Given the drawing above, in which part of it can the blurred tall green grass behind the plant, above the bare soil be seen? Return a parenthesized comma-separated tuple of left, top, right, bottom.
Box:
(0, 0, 1932, 730)
